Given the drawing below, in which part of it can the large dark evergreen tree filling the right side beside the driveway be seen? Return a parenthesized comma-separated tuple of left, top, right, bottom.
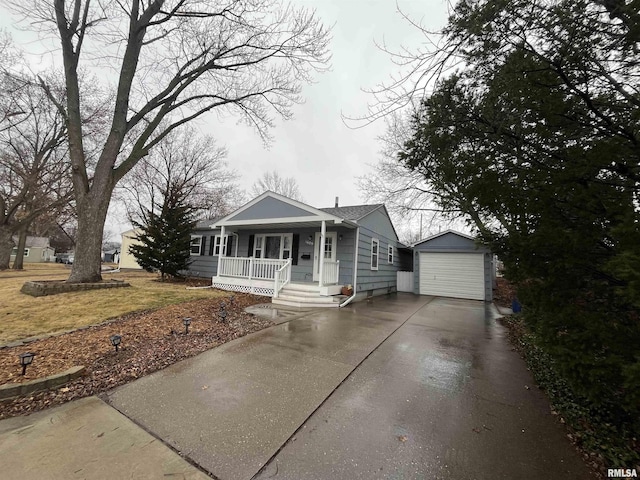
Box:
(378, 0, 640, 452)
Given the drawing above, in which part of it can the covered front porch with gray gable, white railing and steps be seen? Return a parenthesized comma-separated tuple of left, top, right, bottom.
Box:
(205, 192, 357, 299)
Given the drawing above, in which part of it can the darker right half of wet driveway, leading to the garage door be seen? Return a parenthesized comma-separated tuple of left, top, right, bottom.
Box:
(252, 298, 593, 480)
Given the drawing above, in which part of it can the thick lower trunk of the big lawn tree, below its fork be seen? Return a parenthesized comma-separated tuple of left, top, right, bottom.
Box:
(67, 190, 113, 283)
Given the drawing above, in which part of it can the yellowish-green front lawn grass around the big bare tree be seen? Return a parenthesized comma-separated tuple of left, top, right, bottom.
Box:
(0, 263, 220, 344)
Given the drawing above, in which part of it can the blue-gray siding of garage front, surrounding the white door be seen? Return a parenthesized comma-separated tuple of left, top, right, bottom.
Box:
(413, 232, 493, 301)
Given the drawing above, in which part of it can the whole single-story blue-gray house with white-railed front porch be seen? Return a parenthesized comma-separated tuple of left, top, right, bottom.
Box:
(189, 192, 412, 307)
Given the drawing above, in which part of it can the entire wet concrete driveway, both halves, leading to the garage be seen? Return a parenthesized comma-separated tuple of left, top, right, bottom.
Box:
(102, 294, 591, 480)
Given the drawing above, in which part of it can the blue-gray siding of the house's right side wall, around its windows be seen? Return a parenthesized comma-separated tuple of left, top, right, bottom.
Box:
(356, 227, 400, 294)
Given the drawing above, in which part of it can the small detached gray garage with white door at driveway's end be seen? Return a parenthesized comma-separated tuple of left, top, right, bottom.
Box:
(413, 230, 494, 301)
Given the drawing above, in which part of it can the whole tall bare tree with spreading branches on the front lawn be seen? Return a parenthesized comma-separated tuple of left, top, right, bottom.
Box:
(6, 0, 329, 282)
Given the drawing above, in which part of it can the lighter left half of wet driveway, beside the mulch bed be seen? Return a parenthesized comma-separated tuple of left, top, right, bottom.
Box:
(107, 295, 431, 480)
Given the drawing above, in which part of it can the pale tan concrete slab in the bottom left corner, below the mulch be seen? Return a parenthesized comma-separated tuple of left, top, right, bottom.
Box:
(0, 397, 209, 480)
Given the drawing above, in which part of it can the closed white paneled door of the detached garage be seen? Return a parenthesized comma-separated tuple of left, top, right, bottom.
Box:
(420, 253, 484, 300)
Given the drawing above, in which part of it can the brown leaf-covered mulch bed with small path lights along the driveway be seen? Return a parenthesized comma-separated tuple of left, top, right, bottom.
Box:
(0, 288, 273, 419)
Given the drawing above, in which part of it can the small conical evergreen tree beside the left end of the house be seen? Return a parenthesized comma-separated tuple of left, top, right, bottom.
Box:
(129, 186, 195, 281)
